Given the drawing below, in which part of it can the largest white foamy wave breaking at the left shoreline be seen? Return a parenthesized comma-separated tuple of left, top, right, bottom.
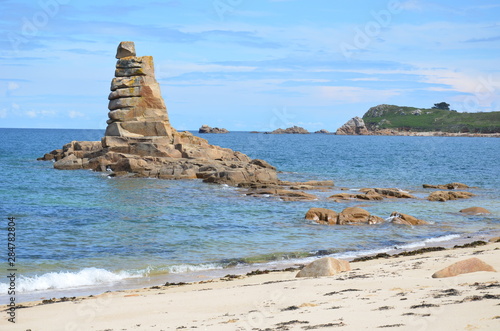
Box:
(0, 268, 141, 293)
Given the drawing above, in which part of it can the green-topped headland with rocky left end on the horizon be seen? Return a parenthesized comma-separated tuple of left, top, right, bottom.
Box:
(336, 102, 500, 135)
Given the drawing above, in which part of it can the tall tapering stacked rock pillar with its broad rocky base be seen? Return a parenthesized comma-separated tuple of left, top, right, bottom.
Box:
(40, 42, 278, 186)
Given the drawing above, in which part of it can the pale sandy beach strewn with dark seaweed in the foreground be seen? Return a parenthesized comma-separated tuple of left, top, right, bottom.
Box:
(0, 242, 500, 331)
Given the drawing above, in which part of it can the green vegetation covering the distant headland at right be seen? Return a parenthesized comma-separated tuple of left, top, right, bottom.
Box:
(363, 102, 500, 133)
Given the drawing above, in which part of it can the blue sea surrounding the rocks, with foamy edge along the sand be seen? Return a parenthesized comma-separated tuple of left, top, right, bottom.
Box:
(0, 129, 500, 303)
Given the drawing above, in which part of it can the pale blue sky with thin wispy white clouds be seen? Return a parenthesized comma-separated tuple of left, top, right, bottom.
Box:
(0, 0, 500, 131)
